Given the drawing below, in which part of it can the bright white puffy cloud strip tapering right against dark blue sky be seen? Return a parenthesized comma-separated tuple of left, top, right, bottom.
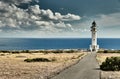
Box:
(41, 9, 80, 21)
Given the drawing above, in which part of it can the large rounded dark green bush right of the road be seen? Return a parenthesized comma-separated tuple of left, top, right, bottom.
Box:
(100, 57, 120, 71)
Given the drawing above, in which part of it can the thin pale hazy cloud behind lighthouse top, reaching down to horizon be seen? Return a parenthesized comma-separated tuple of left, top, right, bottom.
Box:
(70, 12, 120, 38)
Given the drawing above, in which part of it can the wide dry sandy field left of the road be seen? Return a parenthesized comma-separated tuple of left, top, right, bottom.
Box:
(0, 53, 85, 79)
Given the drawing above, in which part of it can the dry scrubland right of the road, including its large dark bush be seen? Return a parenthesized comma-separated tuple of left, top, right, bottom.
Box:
(97, 50, 120, 79)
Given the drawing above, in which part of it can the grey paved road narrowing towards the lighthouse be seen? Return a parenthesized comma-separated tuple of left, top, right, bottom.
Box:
(52, 53, 100, 79)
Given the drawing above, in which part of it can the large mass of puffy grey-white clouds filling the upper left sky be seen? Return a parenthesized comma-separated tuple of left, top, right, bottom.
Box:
(0, 0, 81, 32)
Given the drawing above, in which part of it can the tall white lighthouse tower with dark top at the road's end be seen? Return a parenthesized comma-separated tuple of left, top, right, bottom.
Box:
(90, 21, 99, 52)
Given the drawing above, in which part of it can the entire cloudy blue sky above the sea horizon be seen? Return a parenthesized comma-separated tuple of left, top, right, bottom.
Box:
(0, 0, 120, 38)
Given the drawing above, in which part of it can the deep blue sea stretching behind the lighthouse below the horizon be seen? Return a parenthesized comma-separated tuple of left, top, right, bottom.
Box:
(0, 38, 120, 50)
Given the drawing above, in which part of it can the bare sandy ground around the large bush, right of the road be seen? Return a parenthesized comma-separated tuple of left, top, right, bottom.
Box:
(97, 53, 120, 79)
